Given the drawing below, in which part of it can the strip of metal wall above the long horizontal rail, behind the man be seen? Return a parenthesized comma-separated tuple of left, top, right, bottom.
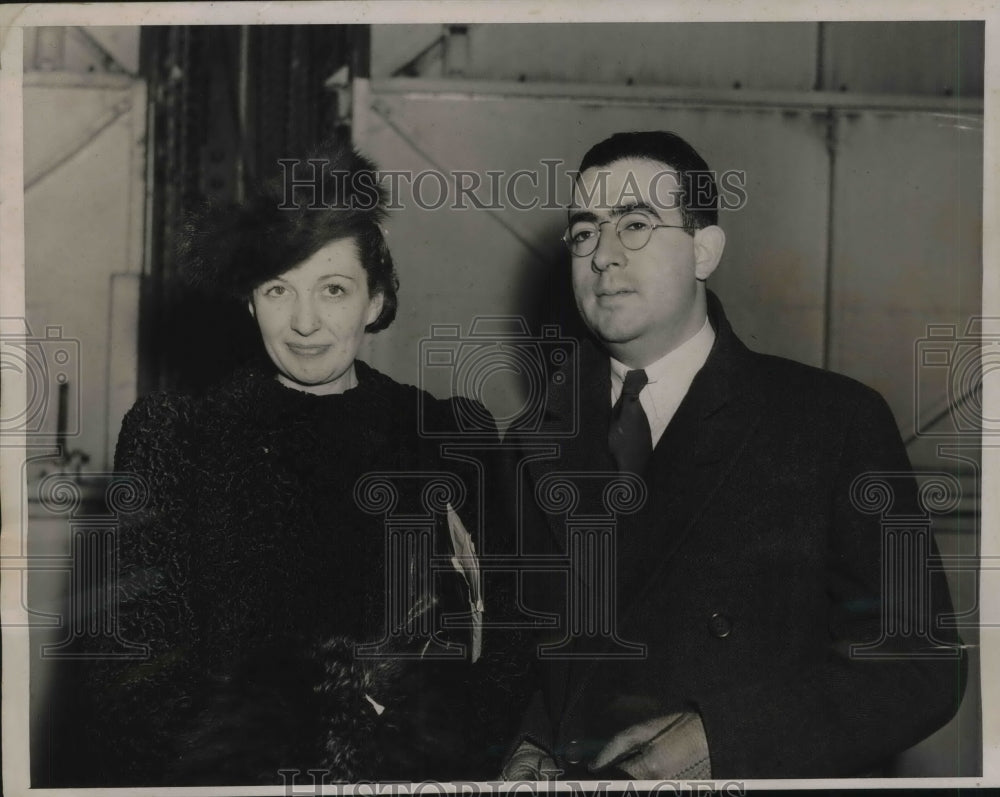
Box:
(371, 21, 985, 97)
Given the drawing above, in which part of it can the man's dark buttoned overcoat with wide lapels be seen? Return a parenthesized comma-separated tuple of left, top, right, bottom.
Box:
(521, 294, 966, 778)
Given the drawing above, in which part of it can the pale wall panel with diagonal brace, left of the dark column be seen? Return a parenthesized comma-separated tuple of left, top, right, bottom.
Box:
(24, 73, 146, 470)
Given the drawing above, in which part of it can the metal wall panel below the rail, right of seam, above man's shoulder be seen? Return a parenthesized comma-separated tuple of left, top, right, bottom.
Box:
(830, 112, 983, 435)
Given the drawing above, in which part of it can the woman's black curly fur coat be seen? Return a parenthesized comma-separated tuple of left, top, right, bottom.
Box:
(59, 362, 522, 786)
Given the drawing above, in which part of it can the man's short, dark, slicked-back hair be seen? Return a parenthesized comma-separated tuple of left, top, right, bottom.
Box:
(580, 130, 719, 232)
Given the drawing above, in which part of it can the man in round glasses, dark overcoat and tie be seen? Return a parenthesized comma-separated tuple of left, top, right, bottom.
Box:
(505, 132, 965, 779)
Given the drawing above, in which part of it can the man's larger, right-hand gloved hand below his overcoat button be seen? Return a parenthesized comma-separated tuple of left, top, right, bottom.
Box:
(590, 712, 712, 780)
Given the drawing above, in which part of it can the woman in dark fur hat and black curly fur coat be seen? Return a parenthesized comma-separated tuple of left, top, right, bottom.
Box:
(78, 143, 506, 785)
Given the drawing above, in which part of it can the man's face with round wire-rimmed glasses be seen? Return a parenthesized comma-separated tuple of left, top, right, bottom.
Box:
(570, 158, 724, 368)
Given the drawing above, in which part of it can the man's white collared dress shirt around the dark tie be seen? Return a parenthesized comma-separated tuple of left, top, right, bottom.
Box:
(611, 317, 715, 448)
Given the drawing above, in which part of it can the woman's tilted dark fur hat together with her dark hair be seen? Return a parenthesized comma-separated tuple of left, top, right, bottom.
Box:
(178, 144, 399, 332)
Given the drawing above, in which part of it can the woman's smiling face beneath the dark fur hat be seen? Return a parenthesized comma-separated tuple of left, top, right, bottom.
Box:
(250, 238, 382, 393)
